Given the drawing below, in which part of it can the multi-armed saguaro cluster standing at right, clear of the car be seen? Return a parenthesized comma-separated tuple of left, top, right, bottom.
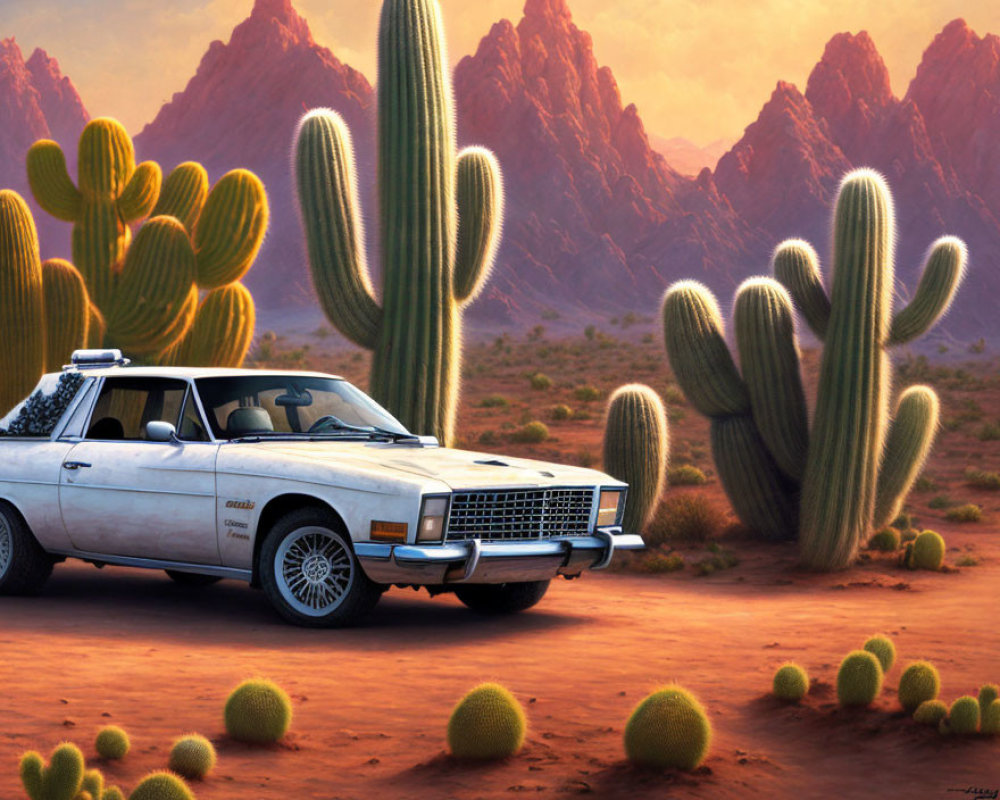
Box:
(663, 170, 966, 569)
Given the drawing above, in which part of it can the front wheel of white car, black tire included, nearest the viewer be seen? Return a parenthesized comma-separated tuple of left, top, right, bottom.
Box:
(258, 508, 386, 628)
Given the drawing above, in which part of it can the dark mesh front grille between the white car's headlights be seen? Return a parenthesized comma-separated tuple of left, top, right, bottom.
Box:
(446, 488, 594, 541)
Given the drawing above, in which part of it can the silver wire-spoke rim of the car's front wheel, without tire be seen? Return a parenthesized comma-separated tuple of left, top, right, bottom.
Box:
(274, 525, 355, 617)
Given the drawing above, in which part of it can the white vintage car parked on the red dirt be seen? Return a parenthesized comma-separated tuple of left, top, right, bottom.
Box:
(0, 350, 643, 626)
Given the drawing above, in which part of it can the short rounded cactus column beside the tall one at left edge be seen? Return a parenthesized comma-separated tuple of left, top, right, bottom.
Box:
(42, 258, 91, 372)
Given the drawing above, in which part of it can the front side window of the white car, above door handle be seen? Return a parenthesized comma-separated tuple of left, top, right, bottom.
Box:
(86, 378, 188, 442)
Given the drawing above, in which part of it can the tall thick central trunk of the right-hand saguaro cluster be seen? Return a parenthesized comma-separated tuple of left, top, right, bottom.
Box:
(799, 170, 894, 570)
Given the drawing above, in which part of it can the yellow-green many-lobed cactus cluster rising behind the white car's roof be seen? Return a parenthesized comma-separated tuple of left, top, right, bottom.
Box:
(27, 118, 268, 366)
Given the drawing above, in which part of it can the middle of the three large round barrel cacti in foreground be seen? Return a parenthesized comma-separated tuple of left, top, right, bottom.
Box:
(448, 683, 527, 760)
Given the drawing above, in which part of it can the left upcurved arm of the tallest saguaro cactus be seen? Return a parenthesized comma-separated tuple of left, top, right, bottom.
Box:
(295, 109, 382, 349)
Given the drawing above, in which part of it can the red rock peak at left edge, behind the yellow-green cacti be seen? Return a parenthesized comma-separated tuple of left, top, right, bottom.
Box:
(0, 37, 90, 258)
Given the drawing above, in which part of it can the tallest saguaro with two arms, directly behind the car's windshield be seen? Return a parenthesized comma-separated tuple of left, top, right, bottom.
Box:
(295, 0, 503, 443)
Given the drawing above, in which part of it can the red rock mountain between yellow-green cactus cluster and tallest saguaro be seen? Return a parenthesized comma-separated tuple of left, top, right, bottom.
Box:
(135, 0, 373, 306)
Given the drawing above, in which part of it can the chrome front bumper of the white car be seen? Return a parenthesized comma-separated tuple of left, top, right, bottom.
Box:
(354, 528, 645, 585)
